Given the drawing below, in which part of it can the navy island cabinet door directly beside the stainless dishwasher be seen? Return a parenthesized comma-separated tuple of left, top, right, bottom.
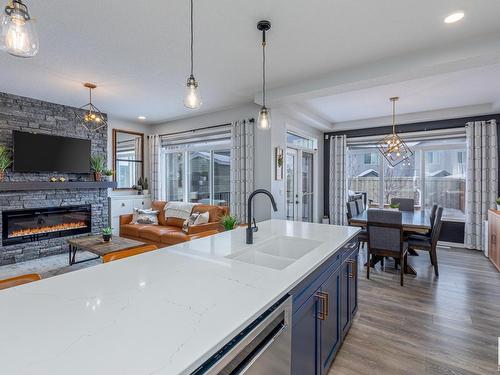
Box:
(292, 294, 319, 375)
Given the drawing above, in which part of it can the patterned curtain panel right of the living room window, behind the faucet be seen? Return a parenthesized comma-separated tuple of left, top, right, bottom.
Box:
(230, 120, 254, 223)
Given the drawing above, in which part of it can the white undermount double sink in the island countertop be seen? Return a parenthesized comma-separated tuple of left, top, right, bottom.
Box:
(226, 236, 322, 270)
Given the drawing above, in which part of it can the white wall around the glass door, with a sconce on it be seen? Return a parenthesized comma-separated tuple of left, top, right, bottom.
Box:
(270, 109, 324, 222)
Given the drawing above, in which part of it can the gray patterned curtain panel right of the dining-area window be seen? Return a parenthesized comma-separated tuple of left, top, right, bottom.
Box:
(465, 120, 498, 250)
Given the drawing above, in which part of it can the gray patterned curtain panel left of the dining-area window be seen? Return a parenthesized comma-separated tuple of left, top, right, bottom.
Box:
(329, 135, 347, 225)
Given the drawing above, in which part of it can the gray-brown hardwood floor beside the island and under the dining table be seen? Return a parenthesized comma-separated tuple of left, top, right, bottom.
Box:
(329, 248, 500, 375)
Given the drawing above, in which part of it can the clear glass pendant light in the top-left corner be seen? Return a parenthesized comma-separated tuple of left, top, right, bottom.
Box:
(0, 0, 38, 57)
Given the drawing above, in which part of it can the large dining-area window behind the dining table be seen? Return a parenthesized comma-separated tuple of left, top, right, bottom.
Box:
(347, 138, 466, 220)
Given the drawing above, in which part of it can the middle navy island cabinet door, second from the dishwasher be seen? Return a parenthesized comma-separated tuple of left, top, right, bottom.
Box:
(317, 268, 340, 374)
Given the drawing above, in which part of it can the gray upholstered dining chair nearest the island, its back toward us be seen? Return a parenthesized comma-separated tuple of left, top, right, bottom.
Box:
(366, 209, 408, 286)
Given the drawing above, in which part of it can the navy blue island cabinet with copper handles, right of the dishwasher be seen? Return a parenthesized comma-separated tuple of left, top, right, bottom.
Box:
(291, 239, 358, 375)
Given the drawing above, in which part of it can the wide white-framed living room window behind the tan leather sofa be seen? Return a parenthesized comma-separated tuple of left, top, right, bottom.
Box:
(164, 133, 231, 206)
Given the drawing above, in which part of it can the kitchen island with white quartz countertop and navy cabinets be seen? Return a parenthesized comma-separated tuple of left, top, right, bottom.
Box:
(0, 220, 359, 375)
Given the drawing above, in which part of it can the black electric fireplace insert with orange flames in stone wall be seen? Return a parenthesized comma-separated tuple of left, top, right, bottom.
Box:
(2, 204, 92, 246)
